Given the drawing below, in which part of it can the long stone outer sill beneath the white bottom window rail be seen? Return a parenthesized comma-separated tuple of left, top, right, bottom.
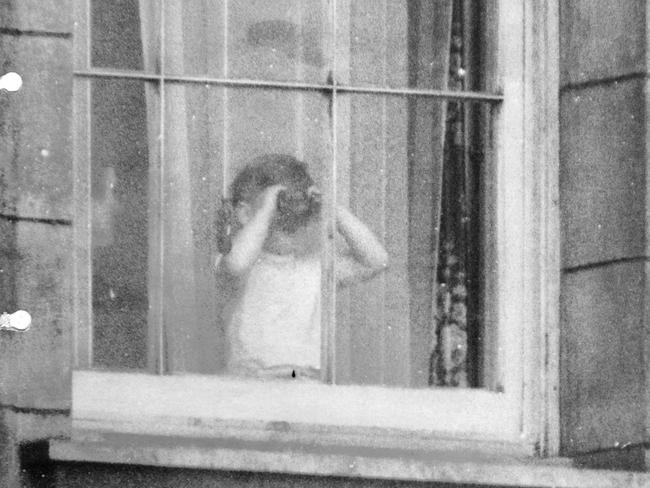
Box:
(50, 434, 650, 488)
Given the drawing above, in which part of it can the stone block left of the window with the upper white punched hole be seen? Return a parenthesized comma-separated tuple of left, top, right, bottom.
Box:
(0, 35, 72, 219)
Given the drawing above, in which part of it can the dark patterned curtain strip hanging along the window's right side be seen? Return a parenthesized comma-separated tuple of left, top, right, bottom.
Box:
(430, 0, 470, 387)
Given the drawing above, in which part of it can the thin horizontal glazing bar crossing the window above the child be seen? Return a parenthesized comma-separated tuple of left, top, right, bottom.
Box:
(74, 70, 503, 103)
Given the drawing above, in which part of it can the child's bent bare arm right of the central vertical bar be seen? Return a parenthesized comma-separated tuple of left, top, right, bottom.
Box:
(336, 207, 388, 285)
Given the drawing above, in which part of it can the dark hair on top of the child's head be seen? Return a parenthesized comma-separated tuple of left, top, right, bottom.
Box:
(230, 154, 314, 206)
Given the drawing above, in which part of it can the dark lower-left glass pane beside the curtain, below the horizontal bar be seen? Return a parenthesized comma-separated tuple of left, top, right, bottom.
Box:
(90, 80, 150, 368)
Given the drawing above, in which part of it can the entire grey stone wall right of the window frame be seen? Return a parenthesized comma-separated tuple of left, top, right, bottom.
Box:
(560, 0, 648, 467)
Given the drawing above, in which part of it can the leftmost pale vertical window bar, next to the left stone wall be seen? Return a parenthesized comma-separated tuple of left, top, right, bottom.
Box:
(72, 0, 93, 369)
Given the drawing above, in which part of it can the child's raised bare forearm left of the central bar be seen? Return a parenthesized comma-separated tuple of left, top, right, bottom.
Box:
(217, 185, 284, 277)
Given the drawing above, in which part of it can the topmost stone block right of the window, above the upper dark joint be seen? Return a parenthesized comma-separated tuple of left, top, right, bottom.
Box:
(559, 0, 647, 85)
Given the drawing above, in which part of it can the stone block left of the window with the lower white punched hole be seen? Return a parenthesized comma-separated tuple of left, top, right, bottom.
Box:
(0, 222, 73, 409)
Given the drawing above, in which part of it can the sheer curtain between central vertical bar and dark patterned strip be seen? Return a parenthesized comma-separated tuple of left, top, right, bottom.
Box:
(336, 0, 452, 386)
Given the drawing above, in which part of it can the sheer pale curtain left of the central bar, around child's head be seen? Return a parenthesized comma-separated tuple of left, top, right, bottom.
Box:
(140, 0, 329, 373)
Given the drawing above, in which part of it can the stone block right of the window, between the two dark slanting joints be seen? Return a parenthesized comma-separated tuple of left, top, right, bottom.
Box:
(560, 80, 647, 268)
